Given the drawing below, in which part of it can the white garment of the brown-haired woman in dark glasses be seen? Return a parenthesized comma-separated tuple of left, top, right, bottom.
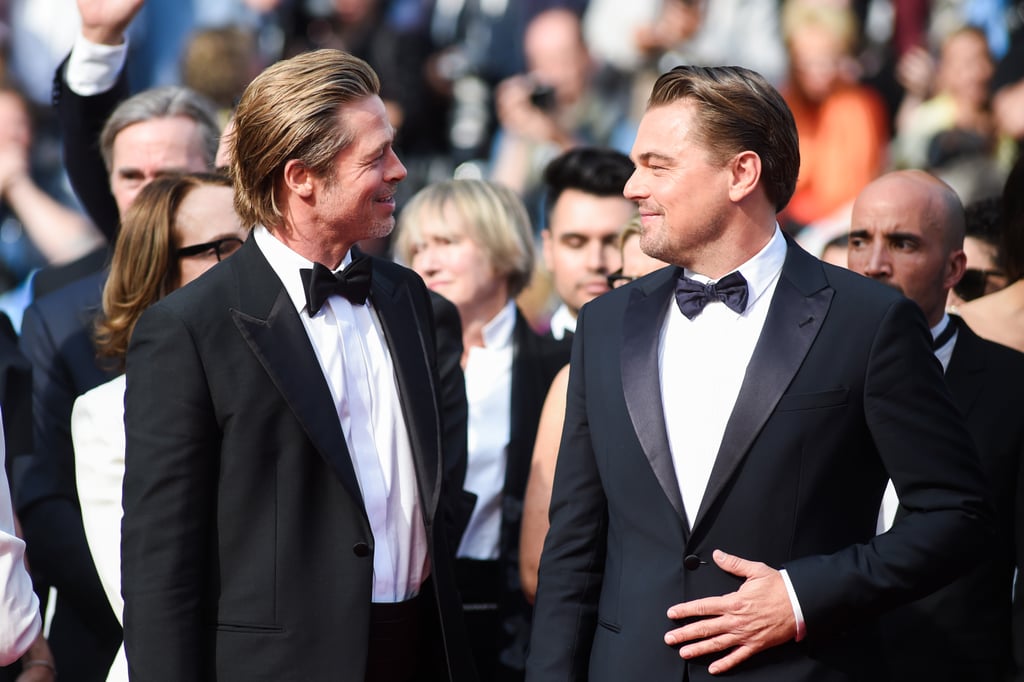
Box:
(71, 374, 128, 682)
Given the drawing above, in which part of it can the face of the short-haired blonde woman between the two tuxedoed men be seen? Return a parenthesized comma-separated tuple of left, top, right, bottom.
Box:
(410, 206, 509, 321)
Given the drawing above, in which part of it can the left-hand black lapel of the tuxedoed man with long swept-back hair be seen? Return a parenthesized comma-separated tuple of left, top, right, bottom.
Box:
(225, 239, 364, 508)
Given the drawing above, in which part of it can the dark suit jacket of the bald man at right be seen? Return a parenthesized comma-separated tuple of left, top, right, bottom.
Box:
(880, 316, 1024, 682)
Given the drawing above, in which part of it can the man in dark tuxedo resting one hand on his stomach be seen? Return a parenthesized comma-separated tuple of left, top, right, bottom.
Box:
(527, 67, 991, 682)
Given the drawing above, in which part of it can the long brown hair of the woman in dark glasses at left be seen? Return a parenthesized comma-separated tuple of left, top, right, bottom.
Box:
(94, 173, 231, 369)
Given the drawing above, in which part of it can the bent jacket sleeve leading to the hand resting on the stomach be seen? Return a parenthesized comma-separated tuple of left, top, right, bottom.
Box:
(785, 300, 994, 638)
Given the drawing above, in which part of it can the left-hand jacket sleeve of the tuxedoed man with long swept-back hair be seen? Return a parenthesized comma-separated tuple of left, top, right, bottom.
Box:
(121, 304, 220, 682)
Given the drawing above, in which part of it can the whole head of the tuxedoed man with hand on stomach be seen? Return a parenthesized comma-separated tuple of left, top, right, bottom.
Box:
(626, 67, 800, 270)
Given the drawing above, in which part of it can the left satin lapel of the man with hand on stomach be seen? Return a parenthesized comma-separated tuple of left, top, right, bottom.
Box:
(621, 267, 688, 522)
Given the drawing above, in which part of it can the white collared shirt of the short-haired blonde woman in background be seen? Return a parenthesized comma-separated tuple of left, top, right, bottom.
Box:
(456, 301, 515, 560)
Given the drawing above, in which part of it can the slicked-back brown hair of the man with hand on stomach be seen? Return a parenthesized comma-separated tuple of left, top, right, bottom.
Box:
(647, 66, 800, 211)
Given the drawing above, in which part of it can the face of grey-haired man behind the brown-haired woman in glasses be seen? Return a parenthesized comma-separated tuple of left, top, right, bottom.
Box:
(111, 116, 209, 215)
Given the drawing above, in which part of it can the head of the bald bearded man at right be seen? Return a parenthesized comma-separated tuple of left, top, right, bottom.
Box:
(848, 170, 966, 327)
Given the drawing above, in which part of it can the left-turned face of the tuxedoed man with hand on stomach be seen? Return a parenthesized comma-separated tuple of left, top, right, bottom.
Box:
(625, 100, 731, 274)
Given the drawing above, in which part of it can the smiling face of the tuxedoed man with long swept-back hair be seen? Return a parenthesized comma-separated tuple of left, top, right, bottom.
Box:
(313, 95, 407, 241)
